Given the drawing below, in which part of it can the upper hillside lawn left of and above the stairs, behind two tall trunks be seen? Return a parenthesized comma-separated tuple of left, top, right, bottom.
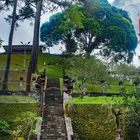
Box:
(0, 54, 62, 80)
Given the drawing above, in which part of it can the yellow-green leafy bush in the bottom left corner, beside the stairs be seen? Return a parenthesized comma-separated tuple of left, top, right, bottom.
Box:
(0, 112, 38, 140)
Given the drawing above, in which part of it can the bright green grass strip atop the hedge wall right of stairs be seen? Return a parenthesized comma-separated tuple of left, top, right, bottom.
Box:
(66, 96, 123, 104)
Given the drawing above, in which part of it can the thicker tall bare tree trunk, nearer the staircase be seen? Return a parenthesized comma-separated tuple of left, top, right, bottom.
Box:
(26, 0, 43, 92)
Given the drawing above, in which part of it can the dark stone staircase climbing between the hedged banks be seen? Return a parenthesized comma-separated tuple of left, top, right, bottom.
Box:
(40, 79, 67, 140)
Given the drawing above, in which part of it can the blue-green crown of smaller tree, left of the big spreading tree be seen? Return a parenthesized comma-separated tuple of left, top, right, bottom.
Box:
(40, 9, 77, 54)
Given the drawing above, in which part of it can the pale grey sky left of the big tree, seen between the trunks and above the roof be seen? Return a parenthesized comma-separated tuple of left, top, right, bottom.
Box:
(0, 7, 60, 53)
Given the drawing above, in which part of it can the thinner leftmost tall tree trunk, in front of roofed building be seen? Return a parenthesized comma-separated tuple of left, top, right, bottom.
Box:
(3, 0, 18, 90)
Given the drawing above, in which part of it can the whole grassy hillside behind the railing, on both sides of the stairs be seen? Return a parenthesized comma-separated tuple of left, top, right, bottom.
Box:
(0, 54, 138, 93)
